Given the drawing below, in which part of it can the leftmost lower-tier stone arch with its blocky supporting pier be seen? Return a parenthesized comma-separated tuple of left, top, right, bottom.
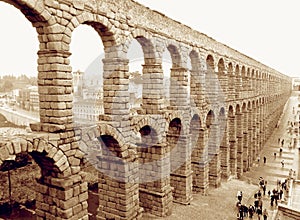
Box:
(0, 136, 88, 219)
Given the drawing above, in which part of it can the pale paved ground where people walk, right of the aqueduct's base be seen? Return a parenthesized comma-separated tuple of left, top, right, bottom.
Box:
(143, 94, 300, 220)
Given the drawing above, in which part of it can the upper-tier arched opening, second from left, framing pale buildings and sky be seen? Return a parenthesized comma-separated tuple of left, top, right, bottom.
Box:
(70, 24, 104, 126)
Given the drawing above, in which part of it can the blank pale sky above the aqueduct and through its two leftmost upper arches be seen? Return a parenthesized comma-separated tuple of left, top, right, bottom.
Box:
(0, 0, 300, 77)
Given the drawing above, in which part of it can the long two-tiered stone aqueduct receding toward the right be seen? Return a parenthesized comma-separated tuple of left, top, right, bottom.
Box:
(0, 0, 291, 219)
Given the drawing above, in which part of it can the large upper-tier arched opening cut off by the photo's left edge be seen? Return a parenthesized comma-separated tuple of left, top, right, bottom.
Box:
(0, 1, 42, 127)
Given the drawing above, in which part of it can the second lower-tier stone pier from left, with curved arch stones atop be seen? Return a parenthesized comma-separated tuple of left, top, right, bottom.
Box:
(95, 129, 142, 218)
